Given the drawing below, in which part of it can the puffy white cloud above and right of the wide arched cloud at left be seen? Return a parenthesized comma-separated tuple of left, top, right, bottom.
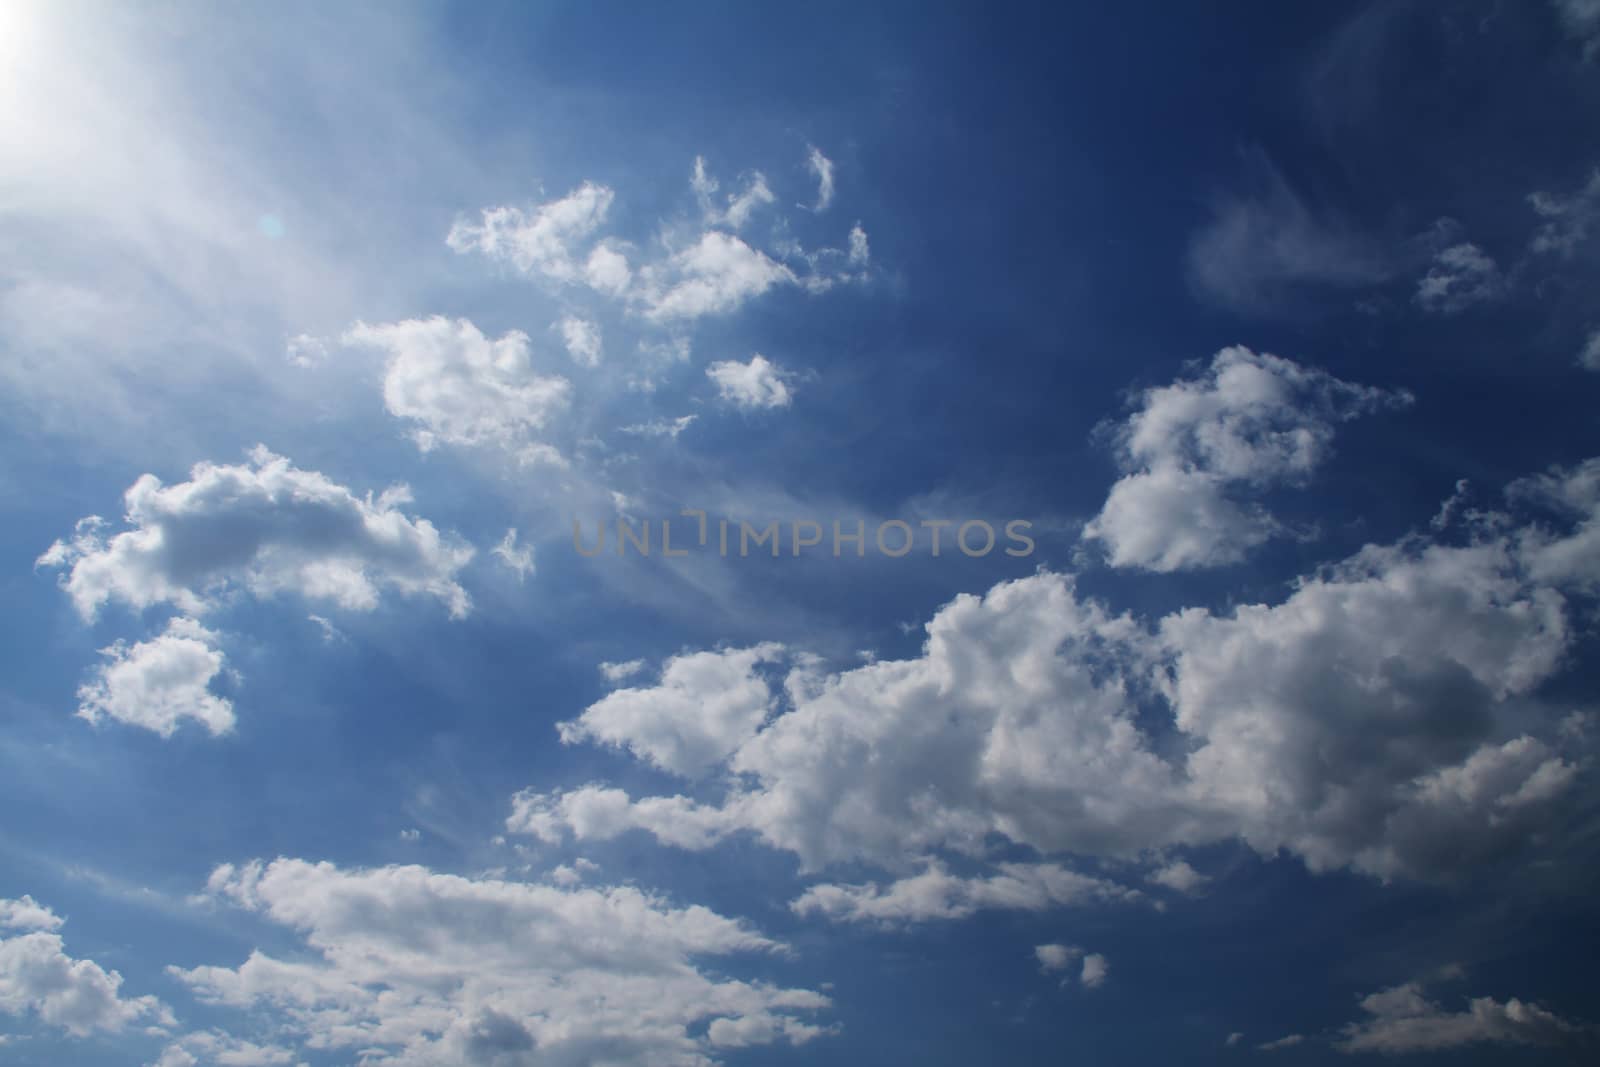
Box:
(344, 315, 571, 462)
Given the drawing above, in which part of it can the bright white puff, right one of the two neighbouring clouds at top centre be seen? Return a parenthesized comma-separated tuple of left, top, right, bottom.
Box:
(635, 230, 798, 322)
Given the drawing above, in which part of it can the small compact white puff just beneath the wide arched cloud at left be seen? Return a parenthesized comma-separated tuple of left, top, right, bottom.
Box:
(78, 617, 234, 737)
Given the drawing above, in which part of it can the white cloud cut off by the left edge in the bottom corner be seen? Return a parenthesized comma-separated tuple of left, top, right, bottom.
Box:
(0, 896, 173, 1037)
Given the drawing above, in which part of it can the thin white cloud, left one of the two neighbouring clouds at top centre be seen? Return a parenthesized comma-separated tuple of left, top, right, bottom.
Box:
(445, 182, 616, 283)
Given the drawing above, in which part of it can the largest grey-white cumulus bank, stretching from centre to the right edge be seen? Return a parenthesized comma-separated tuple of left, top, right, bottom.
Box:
(507, 460, 1600, 895)
